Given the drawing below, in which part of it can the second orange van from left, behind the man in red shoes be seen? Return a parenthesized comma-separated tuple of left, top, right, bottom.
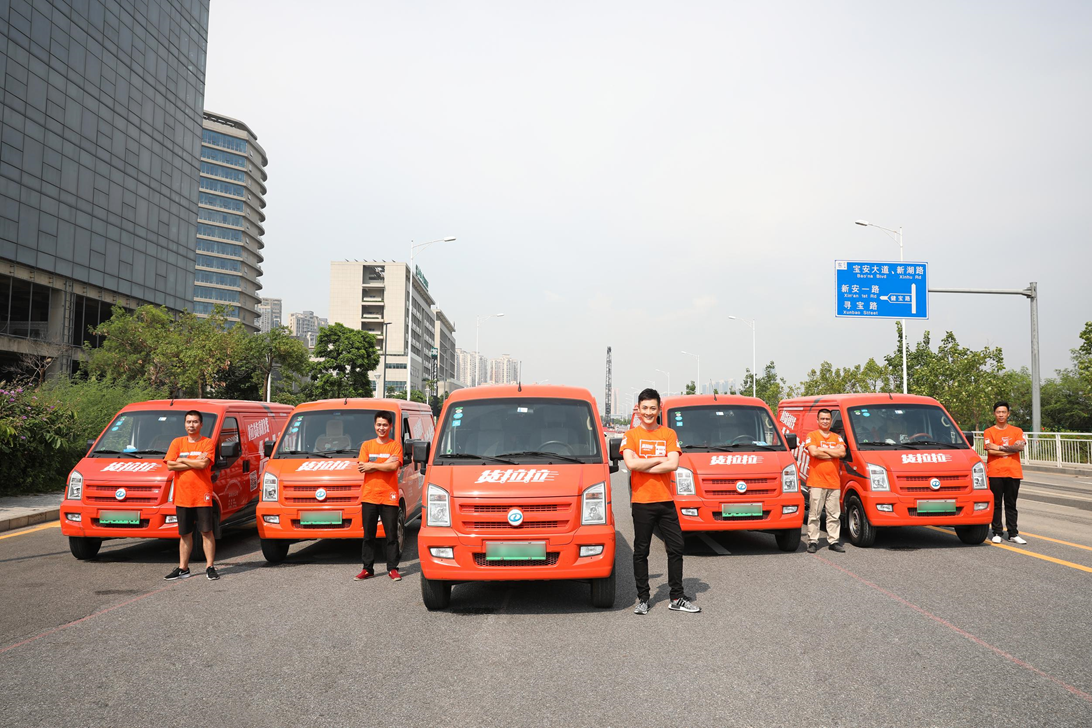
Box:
(258, 398, 434, 563)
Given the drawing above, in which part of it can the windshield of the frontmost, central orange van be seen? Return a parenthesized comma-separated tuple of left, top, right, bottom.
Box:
(435, 397, 603, 465)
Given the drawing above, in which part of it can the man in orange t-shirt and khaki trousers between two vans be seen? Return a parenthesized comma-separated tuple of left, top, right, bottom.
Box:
(807, 408, 845, 553)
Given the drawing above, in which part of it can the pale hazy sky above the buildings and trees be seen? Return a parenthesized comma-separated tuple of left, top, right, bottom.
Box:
(205, 0, 1092, 401)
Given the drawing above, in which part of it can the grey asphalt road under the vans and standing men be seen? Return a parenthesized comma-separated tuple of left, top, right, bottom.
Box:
(0, 474, 1092, 728)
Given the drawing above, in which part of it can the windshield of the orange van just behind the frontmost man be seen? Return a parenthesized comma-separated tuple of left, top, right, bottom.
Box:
(664, 405, 785, 452)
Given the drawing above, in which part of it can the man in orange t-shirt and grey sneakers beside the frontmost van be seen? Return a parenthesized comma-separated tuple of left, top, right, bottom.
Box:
(620, 390, 701, 614)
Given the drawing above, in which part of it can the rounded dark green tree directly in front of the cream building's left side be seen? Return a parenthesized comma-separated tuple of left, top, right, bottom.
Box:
(310, 323, 379, 398)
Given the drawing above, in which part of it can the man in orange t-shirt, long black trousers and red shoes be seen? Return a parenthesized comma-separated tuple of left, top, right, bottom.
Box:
(353, 411, 402, 582)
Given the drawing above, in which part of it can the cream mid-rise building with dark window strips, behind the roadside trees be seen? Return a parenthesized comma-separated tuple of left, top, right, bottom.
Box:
(330, 261, 436, 396)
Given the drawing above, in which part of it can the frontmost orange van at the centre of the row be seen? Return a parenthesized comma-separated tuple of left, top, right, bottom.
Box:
(415, 384, 617, 609)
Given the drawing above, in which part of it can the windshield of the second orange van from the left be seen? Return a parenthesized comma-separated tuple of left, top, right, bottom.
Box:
(273, 409, 399, 458)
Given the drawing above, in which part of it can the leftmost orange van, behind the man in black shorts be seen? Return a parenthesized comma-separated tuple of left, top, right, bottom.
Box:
(60, 399, 292, 559)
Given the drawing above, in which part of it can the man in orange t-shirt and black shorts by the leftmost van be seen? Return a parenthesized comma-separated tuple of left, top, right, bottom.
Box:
(164, 409, 219, 582)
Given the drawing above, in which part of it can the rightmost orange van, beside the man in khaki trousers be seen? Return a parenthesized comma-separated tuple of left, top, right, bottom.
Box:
(778, 394, 994, 547)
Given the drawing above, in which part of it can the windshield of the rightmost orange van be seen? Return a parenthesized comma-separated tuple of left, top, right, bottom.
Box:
(846, 404, 968, 450)
